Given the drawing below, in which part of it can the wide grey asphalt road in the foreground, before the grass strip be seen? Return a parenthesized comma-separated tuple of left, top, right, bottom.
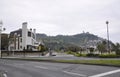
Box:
(0, 59, 120, 77)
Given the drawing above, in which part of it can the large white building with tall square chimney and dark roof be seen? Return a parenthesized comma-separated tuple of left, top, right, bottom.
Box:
(8, 22, 40, 51)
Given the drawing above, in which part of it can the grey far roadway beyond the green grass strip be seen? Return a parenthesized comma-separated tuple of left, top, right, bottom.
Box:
(3, 52, 120, 60)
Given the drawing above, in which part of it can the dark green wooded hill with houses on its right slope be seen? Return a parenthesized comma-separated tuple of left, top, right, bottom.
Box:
(36, 32, 104, 49)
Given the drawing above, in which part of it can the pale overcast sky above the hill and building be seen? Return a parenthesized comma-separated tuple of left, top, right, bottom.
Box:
(0, 0, 120, 42)
